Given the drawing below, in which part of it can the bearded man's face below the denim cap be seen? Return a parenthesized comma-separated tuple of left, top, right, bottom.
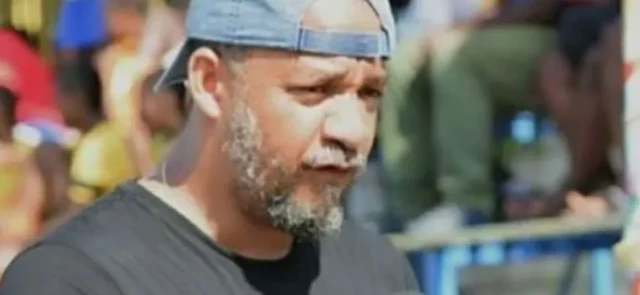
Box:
(223, 50, 384, 238)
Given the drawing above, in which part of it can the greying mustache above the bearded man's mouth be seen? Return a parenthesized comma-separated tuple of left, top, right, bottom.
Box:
(302, 145, 367, 169)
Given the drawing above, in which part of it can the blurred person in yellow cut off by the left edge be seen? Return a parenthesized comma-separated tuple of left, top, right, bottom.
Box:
(0, 84, 45, 272)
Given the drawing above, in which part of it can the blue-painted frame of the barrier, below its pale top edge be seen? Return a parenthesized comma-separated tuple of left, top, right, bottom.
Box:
(409, 232, 620, 295)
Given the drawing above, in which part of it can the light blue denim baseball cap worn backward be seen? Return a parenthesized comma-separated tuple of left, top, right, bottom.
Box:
(154, 0, 396, 90)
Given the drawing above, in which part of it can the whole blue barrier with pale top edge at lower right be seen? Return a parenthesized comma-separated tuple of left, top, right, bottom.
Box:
(394, 216, 621, 295)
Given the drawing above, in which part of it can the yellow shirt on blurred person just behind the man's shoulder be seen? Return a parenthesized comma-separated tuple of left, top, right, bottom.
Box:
(69, 122, 170, 205)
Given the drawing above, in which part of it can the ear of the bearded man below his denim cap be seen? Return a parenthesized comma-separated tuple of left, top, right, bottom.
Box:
(186, 47, 220, 119)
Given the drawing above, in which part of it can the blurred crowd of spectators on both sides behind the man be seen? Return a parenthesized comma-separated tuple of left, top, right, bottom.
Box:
(0, 0, 627, 290)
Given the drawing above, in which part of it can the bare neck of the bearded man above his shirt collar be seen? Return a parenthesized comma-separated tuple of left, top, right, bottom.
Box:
(141, 134, 293, 260)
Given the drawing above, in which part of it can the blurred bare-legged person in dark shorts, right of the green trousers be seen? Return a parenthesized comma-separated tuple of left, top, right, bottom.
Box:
(539, 1, 623, 214)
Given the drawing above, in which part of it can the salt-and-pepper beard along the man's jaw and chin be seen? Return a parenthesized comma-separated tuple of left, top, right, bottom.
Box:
(222, 100, 344, 240)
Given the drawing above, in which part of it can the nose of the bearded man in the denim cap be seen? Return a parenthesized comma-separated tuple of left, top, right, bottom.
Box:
(323, 94, 368, 152)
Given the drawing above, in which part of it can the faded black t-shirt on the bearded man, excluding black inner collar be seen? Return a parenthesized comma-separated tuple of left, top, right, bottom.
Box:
(0, 182, 417, 295)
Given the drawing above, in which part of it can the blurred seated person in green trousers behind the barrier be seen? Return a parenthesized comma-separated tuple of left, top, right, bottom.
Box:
(380, 0, 620, 232)
